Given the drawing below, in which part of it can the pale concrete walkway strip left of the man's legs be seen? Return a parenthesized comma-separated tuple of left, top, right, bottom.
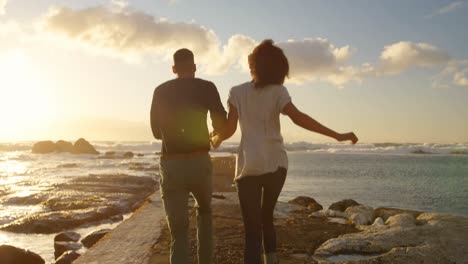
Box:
(73, 191, 164, 264)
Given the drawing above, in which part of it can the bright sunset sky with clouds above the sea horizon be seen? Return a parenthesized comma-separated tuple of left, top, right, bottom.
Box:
(0, 0, 468, 143)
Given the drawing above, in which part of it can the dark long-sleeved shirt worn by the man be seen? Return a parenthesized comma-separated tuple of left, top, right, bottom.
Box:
(151, 78, 226, 155)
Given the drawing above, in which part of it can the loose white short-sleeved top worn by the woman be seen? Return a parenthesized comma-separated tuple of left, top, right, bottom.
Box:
(228, 82, 291, 179)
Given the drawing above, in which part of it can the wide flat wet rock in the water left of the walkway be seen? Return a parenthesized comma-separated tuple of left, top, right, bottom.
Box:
(0, 174, 157, 234)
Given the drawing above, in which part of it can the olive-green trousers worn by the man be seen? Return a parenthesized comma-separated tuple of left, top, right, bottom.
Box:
(159, 154, 213, 264)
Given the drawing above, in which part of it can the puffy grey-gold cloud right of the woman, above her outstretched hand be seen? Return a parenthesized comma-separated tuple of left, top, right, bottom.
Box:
(376, 41, 450, 75)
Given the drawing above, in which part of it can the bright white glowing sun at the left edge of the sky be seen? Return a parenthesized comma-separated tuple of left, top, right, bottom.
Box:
(0, 50, 52, 141)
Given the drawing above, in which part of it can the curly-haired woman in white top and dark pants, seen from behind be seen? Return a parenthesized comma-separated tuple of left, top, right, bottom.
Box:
(213, 40, 358, 264)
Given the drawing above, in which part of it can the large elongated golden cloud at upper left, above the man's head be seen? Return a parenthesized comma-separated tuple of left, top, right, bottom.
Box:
(41, 6, 218, 61)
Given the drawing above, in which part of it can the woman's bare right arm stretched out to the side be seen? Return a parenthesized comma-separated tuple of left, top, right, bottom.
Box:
(283, 102, 358, 144)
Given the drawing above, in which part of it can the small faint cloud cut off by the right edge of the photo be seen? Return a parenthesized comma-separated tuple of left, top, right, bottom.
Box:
(432, 60, 468, 88)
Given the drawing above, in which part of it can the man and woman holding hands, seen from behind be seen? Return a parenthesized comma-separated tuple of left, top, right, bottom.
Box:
(151, 40, 358, 264)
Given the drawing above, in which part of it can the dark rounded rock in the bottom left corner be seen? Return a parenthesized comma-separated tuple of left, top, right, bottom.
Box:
(0, 245, 45, 264)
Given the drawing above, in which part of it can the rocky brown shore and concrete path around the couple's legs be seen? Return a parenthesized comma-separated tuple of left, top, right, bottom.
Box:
(74, 157, 468, 264)
